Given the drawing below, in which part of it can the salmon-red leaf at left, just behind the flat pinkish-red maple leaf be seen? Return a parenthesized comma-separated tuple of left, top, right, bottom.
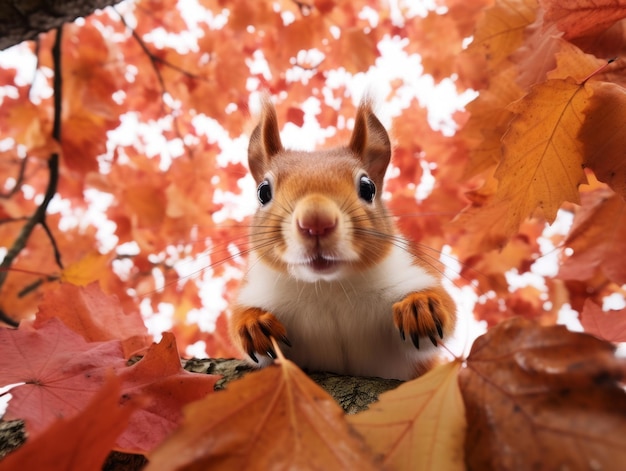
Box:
(34, 282, 152, 358)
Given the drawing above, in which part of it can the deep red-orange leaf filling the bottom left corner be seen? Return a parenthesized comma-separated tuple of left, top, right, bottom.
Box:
(0, 376, 139, 471)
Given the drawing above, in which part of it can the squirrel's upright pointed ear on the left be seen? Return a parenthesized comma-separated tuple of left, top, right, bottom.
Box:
(248, 95, 283, 182)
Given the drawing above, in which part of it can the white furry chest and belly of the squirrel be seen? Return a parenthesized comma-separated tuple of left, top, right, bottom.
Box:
(238, 246, 436, 379)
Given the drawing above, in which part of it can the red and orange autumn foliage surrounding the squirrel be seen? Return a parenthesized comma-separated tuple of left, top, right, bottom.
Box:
(0, 0, 626, 470)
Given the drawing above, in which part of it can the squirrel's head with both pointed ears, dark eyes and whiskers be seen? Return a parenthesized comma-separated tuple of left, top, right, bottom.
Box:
(248, 98, 394, 281)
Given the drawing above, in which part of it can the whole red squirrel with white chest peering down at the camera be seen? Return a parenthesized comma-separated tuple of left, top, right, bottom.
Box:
(230, 98, 456, 380)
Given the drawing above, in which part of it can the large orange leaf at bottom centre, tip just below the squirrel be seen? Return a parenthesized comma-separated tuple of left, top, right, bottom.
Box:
(146, 359, 376, 471)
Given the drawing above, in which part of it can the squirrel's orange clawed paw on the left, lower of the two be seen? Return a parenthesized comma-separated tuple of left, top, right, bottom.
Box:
(233, 307, 291, 363)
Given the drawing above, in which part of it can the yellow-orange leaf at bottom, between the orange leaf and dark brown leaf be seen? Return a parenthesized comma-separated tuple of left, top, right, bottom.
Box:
(347, 361, 466, 470)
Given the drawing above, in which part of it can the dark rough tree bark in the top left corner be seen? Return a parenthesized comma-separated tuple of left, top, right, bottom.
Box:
(0, 0, 120, 50)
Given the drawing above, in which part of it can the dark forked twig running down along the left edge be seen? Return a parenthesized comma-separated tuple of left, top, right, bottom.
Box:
(0, 26, 63, 325)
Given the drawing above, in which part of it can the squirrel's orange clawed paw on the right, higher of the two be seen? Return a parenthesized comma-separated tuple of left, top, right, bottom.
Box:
(393, 289, 453, 348)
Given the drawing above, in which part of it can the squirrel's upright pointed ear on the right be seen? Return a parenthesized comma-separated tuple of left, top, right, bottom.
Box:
(348, 98, 391, 184)
